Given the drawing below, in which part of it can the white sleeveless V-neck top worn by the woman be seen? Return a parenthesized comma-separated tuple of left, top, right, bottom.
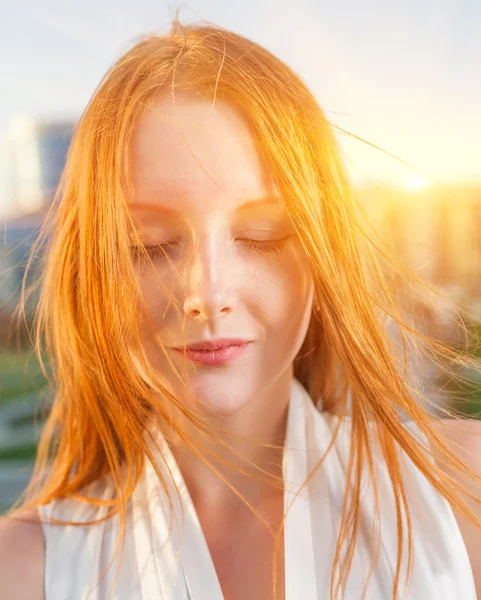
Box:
(39, 379, 476, 600)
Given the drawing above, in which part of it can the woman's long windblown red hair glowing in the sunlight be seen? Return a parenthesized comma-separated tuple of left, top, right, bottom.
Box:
(3, 19, 481, 597)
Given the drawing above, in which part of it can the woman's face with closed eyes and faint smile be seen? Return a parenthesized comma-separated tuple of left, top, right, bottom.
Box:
(130, 94, 313, 416)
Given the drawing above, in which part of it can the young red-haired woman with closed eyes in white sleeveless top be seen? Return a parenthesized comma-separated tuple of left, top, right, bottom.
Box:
(0, 21, 481, 600)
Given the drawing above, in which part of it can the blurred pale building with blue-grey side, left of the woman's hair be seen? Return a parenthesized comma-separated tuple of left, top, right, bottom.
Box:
(8, 118, 75, 216)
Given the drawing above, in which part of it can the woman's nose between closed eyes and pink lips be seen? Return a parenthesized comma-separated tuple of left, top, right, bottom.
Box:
(184, 241, 236, 321)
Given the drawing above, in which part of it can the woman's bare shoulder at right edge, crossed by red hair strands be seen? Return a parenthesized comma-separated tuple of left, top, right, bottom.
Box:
(432, 419, 481, 597)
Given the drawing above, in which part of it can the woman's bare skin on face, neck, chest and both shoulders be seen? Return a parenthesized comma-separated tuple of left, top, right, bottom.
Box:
(0, 95, 481, 600)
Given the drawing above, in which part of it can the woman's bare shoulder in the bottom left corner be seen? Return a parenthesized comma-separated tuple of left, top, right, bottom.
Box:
(0, 512, 45, 600)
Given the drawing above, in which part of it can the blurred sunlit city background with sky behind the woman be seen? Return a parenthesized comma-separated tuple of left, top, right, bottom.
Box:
(0, 0, 481, 513)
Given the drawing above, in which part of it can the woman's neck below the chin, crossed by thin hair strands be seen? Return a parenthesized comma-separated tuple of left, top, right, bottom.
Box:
(158, 371, 293, 510)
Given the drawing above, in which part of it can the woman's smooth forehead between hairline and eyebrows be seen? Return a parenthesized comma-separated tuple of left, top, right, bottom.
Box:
(130, 93, 277, 212)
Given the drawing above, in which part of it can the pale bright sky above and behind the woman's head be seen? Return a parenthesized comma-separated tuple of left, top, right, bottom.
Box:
(0, 0, 481, 214)
